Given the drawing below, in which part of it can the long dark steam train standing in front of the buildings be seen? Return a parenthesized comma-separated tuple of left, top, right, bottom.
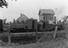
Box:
(10, 19, 64, 33)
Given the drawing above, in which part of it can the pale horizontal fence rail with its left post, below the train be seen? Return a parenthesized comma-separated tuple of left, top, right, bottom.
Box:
(0, 30, 68, 45)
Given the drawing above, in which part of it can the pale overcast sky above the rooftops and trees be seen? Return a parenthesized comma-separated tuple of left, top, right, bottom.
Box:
(0, 0, 68, 21)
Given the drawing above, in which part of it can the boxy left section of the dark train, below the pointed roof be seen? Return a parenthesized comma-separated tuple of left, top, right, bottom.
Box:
(10, 19, 37, 33)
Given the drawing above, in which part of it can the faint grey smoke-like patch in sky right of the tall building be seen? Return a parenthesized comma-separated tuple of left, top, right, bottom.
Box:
(54, 6, 66, 20)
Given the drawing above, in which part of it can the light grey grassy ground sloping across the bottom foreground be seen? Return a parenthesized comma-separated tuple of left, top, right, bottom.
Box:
(0, 30, 68, 48)
